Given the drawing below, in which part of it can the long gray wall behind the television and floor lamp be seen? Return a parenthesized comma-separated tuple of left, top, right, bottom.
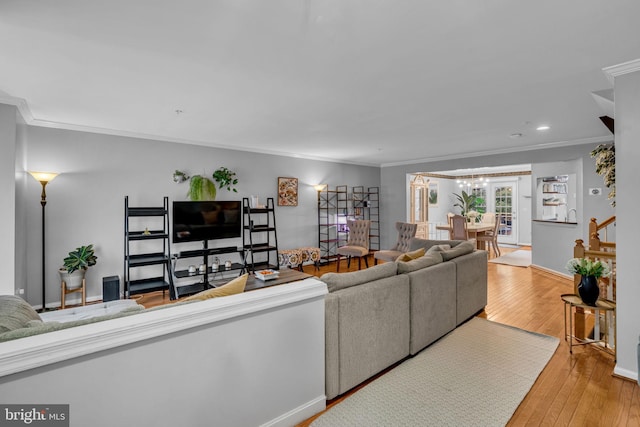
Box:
(17, 126, 385, 305)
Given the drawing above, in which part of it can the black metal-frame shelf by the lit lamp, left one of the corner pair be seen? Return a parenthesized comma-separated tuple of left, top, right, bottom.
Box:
(318, 185, 349, 263)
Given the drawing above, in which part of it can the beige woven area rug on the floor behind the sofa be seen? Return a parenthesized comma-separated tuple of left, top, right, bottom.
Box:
(311, 317, 559, 427)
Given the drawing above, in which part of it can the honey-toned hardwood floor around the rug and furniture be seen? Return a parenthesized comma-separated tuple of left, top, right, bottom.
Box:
(141, 248, 640, 427)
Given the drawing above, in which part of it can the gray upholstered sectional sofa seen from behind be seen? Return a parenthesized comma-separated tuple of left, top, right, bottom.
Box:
(320, 238, 487, 399)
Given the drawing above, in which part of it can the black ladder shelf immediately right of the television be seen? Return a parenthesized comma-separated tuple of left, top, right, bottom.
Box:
(242, 197, 280, 272)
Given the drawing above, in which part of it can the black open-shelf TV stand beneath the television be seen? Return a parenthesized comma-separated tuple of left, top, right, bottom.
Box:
(172, 240, 247, 298)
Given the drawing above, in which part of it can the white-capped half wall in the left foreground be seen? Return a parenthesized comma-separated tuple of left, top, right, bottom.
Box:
(0, 278, 327, 427)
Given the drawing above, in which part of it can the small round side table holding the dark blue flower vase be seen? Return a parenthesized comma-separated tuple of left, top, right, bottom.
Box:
(560, 294, 617, 360)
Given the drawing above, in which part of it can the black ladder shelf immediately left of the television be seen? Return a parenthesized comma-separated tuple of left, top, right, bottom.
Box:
(124, 196, 175, 299)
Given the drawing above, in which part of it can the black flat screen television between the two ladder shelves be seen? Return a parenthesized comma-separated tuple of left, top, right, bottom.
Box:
(173, 200, 242, 243)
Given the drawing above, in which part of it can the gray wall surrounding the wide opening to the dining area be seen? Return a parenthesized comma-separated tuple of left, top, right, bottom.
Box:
(381, 144, 615, 274)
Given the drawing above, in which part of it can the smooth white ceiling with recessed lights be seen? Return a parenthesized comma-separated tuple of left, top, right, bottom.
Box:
(0, 0, 640, 165)
